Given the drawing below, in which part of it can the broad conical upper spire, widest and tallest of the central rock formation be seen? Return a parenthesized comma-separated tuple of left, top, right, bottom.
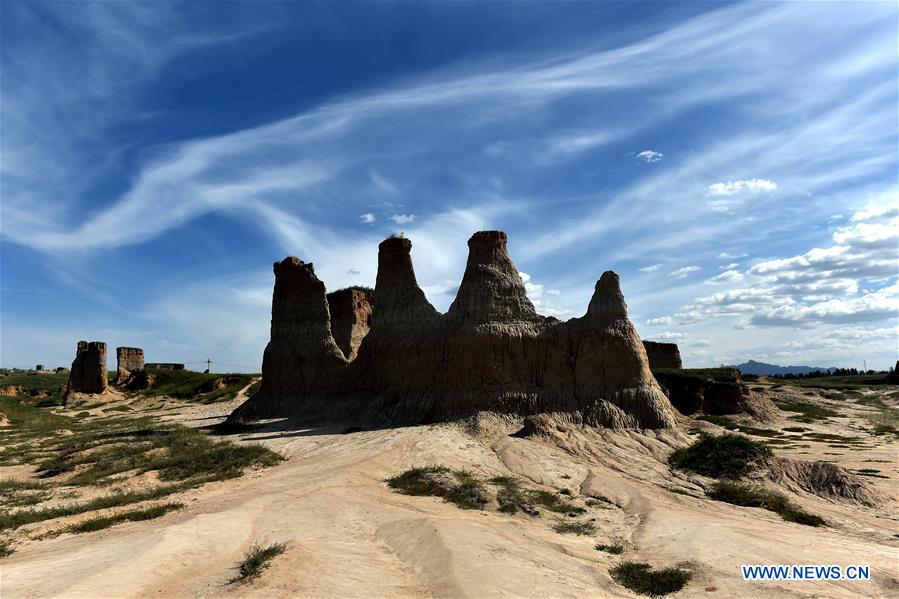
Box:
(447, 231, 540, 323)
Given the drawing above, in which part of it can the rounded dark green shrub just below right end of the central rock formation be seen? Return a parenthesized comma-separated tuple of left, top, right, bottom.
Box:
(668, 434, 772, 479)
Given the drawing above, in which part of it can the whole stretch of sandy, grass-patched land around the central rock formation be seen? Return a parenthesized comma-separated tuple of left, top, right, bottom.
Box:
(0, 372, 899, 598)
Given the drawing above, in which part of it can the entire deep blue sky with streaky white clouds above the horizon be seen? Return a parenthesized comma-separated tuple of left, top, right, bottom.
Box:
(0, 1, 899, 370)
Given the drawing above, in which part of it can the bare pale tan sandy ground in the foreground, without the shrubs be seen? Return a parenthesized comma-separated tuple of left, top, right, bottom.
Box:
(0, 384, 899, 599)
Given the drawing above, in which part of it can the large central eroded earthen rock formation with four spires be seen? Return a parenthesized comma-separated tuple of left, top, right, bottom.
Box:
(230, 231, 675, 428)
